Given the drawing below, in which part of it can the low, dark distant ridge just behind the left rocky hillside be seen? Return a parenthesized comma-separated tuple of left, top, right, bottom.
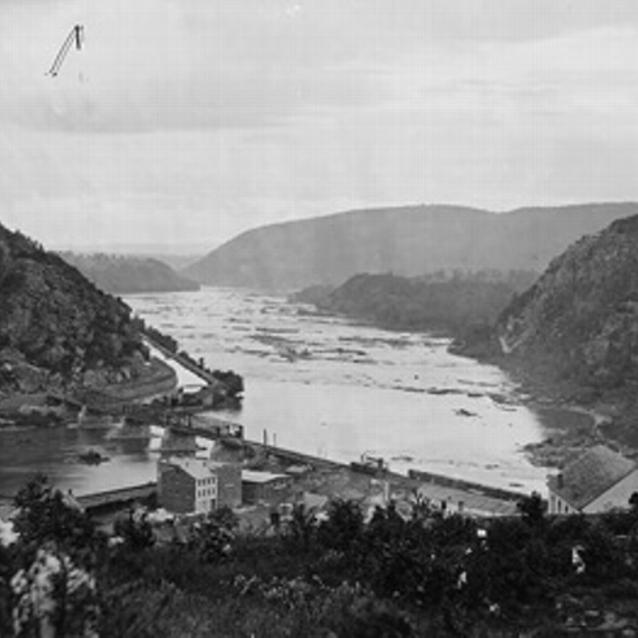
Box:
(60, 252, 199, 295)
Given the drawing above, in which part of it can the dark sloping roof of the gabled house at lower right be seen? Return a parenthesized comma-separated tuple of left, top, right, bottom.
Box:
(547, 445, 636, 509)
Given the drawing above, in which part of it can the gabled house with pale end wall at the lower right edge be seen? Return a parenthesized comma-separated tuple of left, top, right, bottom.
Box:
(547, 445, 638, 514)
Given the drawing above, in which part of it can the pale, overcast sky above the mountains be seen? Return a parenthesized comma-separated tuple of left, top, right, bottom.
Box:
(0, 0, 638, 252)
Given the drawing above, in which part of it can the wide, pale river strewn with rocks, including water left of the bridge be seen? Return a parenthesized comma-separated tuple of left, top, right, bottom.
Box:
(0, 288, 545, 504)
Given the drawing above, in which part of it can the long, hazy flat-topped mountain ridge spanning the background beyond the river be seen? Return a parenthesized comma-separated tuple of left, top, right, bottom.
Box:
(182, 203, 638, 290)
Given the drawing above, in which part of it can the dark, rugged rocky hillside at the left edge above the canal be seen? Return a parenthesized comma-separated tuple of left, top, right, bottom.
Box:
(0, 226, 162, 397)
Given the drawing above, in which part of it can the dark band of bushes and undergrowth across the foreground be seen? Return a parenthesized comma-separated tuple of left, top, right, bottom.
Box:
(0, 480, 638, 638)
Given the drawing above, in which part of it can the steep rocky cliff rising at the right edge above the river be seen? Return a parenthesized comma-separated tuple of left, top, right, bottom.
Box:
(496, 215, 638, 441)
